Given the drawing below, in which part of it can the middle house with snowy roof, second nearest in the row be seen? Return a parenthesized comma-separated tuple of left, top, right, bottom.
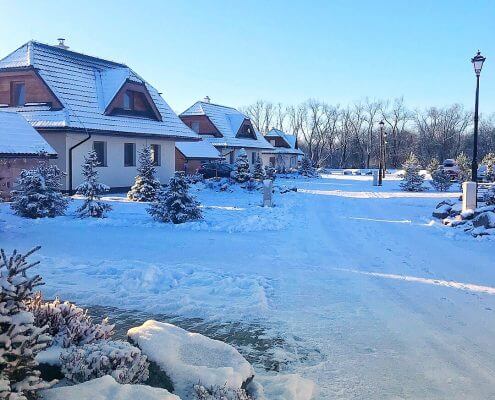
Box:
(179, 97, 272, 166)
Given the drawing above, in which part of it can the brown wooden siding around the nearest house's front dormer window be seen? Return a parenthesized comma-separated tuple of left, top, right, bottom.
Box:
(105, 81, 162, 121)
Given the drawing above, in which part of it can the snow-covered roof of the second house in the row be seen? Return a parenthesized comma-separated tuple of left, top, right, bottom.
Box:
(180, 101, 272, 149)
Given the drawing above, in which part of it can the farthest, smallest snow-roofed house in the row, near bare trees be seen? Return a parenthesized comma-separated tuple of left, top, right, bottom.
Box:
(262, 128, 304, 171)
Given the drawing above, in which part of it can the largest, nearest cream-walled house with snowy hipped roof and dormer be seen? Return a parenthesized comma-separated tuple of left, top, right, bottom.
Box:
(0, 41, 199, 190)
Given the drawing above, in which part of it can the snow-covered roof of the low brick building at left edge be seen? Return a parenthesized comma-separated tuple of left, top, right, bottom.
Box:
(0, 111, 57, 155)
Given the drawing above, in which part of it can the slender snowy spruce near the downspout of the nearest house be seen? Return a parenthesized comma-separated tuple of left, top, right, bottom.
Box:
(76, 151, 112, 218)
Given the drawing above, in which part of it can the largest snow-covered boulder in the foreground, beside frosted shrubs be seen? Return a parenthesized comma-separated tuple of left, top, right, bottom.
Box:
(127, 320, 254, 398)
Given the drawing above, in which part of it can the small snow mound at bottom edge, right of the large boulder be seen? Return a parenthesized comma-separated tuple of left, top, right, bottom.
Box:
(249, 374, 316, 400)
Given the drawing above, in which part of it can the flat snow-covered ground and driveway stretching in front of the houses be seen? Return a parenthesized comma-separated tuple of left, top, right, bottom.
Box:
(0, 175, 495, 399)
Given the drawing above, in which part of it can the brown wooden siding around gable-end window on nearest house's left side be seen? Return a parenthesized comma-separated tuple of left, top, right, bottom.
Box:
(0, 69, 62, 109)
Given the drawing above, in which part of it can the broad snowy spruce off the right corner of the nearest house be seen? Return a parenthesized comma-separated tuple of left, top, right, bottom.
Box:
(148, 172, 202, 224)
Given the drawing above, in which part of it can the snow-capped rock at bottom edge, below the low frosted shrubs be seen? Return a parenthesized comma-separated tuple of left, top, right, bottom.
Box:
(41, 375, 180, 400)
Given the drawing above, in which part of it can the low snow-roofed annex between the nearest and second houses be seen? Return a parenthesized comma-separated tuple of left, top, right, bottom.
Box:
(175, 140, 223, 174)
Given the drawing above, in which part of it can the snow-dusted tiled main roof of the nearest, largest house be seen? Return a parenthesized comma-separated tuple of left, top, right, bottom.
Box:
(0, 41, 198, 140)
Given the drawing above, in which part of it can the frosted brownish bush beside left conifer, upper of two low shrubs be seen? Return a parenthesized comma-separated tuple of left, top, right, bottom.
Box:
(27, 292, 114, 348)
